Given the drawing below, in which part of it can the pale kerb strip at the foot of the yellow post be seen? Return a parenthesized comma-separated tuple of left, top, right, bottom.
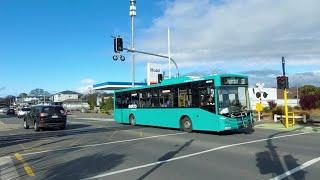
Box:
(255, 123, 320, 133)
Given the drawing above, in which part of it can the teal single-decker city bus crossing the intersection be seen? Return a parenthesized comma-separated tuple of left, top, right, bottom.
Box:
(114, 74, 254, 132)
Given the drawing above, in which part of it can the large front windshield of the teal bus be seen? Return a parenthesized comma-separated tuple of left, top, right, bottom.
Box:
(218, 86, 249, 115)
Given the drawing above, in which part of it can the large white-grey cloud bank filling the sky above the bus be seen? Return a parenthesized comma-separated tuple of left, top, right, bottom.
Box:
(137, 0, 320, 67)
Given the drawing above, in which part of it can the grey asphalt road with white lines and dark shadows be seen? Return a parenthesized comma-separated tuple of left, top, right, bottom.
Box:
(0, 115, 320, 180)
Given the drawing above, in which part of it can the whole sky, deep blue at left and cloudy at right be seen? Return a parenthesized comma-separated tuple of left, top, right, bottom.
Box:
(0, 0, 320, 97)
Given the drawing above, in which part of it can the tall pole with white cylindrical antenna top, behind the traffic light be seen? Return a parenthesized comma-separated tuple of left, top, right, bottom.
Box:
(129, 0, 137, 87)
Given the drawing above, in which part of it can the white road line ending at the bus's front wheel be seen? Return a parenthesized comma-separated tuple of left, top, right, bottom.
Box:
(20, 132, 186, 156)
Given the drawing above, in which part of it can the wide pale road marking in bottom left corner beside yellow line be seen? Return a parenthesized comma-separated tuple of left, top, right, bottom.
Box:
(0, 156, 20, 180)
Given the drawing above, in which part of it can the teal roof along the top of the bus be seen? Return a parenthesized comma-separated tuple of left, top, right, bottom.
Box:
(115, 74, 248, 92)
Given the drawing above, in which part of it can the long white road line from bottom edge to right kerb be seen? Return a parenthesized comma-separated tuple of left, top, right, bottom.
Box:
(82, 132, 309, 180)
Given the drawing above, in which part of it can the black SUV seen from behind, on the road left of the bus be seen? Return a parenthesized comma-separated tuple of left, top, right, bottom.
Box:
(23, 105, 67, 131)
